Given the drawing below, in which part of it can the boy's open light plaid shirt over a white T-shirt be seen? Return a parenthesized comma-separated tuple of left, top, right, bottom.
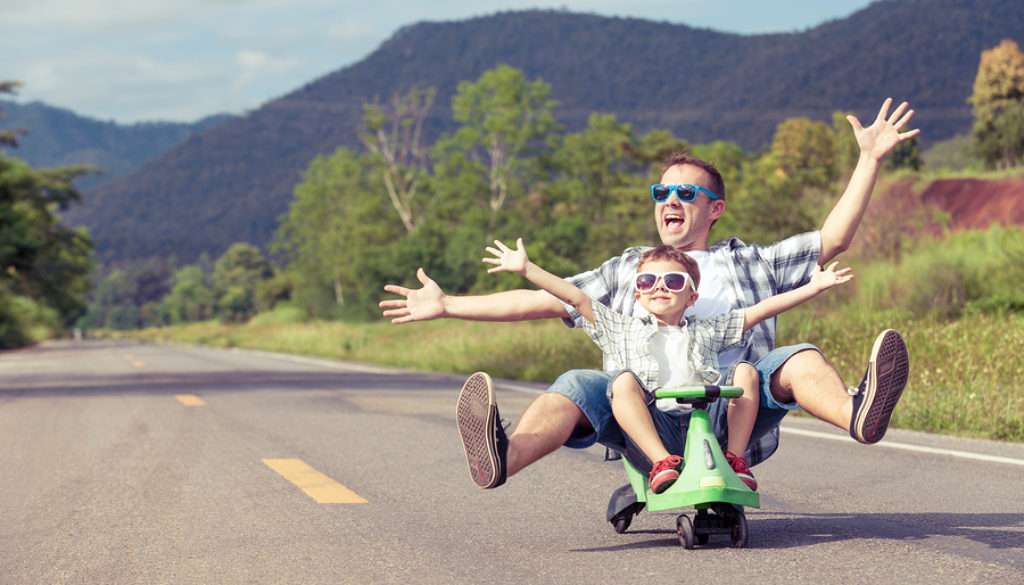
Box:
(583, 303, 743, 390)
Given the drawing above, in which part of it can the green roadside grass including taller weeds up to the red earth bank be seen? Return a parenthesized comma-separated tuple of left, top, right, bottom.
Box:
(103, 227, 1024, 442)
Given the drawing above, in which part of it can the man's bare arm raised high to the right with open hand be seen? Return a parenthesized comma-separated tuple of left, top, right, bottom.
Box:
(818, 97, 921, 265)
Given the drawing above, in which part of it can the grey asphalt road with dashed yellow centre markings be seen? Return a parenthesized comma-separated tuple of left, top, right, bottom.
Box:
(0, 341, 1024, 585)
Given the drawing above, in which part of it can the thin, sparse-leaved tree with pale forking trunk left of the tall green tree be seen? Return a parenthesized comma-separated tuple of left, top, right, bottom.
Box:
(359, 86, 437, 234)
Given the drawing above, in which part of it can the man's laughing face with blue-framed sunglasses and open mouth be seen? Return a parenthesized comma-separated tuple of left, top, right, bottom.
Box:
(654, 165, 725, 250)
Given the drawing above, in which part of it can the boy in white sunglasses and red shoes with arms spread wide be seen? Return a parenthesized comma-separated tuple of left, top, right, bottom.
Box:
(483, 238, 853, 494)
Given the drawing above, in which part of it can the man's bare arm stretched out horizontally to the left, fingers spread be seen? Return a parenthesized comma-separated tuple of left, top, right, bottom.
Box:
(380, 268, 568, 324)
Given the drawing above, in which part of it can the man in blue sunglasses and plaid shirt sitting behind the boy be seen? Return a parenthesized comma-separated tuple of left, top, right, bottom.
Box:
(380, 98, 920, 488)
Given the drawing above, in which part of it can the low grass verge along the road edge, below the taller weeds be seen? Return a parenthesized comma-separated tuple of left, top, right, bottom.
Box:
(108, 303, 1024, 442)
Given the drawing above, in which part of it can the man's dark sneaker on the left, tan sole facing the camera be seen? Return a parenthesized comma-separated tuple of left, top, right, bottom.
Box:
(456, 372, 509, 489)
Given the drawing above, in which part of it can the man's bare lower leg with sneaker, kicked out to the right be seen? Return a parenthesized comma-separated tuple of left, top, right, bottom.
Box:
(771, 329, 909, 444)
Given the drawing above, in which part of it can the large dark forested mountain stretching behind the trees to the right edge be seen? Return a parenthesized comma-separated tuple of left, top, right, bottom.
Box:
(59, 0, 1024, 262)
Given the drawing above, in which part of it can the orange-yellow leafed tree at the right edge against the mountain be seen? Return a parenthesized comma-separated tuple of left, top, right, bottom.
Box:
(968, 39, 1024, 167)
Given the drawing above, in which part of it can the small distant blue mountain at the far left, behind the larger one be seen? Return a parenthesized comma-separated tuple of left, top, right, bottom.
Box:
(0, 100, 229, 189)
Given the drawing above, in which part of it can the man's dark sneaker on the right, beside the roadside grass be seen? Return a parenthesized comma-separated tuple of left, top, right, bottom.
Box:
(850, 329, 910, 445)
